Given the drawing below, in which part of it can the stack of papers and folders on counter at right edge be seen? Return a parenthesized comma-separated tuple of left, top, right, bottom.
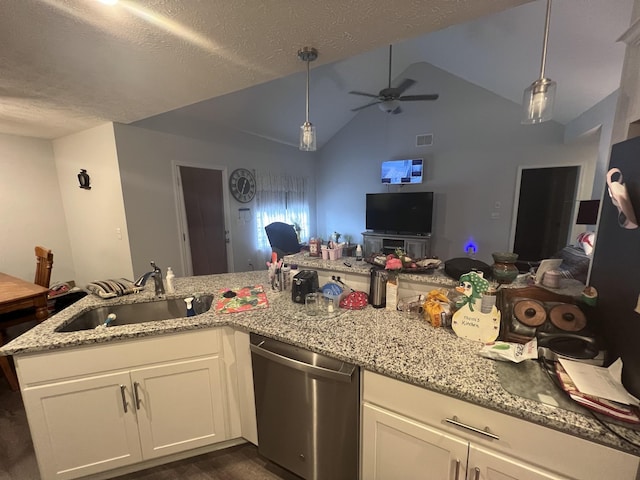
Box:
(556, 359, 640, 424)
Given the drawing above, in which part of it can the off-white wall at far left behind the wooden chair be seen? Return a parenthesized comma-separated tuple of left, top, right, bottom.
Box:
(0, 134, 77, 283)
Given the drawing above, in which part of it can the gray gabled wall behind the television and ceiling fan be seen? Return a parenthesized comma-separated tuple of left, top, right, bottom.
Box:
(316, 63, 597, 263)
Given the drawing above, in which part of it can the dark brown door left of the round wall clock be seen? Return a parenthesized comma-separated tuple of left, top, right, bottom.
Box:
(180, 166, 228, 275)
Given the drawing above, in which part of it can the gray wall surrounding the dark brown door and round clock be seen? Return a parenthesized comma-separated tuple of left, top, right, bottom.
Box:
(115, 121, 315, 275)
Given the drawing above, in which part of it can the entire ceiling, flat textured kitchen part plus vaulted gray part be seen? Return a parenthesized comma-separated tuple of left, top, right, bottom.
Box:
(0, 0, 633, 144)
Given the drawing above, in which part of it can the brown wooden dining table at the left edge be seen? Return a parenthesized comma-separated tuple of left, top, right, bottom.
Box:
(0, 272, 49, 391)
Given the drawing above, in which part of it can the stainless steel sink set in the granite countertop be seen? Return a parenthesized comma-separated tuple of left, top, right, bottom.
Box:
(56, 295, 213, 332)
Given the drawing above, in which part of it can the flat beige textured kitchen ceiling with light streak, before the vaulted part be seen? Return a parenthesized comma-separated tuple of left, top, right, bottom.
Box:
(0, 0, 526, 138)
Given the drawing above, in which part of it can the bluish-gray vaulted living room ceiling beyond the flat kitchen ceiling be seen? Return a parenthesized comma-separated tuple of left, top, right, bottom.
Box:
(138, 0, 633, 146)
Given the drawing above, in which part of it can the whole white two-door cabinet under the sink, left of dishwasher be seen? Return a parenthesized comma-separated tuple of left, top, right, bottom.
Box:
(16, 329, 240, 480)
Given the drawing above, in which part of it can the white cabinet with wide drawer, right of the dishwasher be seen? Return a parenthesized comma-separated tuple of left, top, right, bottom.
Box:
(362, 371, 639, 480)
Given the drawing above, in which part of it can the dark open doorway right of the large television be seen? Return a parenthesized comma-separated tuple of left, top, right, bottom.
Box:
(513, 166, 580, 262)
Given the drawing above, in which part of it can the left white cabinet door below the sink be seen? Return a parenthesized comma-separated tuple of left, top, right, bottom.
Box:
(22, 372, 142, 480)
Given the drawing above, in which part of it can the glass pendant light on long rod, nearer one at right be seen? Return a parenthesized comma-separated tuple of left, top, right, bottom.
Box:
(521, 0, 556, 125)
